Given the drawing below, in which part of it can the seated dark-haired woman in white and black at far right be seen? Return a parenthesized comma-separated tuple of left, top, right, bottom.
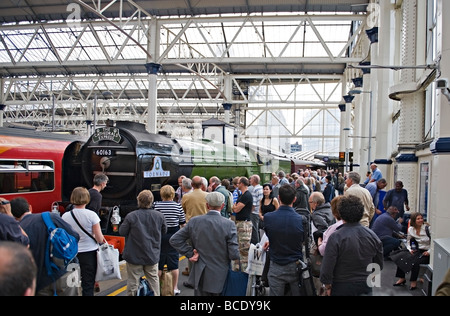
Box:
(394, 212, 431, 291)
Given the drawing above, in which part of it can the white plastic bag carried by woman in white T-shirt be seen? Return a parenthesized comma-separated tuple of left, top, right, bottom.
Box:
(95, 243, 122, 281)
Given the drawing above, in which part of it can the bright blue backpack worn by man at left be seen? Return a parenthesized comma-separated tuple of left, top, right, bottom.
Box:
(41, 212, 78, 277)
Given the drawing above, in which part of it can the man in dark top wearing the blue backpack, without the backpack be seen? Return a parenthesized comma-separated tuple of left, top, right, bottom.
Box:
(11, 197, 80, 296)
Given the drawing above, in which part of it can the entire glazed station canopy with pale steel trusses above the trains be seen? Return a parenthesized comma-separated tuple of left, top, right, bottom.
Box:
(0, 0, 369, 156)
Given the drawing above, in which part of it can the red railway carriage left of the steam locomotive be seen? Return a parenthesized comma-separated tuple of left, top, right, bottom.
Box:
(0, 128, 82, 213)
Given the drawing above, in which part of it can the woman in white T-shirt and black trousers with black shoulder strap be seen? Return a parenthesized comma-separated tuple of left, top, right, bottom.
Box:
(62, 187, 105, 296)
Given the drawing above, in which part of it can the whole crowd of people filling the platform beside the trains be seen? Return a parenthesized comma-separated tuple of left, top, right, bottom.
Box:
(0, 165, 442, 296)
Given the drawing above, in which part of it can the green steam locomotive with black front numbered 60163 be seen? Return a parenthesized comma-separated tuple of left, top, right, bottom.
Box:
(63, 121, 291, 209)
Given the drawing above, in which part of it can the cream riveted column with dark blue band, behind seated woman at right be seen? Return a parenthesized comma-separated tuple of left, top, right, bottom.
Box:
(394, 0, 425, 211)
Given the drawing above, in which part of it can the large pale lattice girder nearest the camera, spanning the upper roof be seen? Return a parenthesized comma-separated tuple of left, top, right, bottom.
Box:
(0, 15, 364, 77)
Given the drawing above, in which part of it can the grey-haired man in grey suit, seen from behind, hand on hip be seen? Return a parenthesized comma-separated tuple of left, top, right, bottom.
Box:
(169, 192, 239, 296)
